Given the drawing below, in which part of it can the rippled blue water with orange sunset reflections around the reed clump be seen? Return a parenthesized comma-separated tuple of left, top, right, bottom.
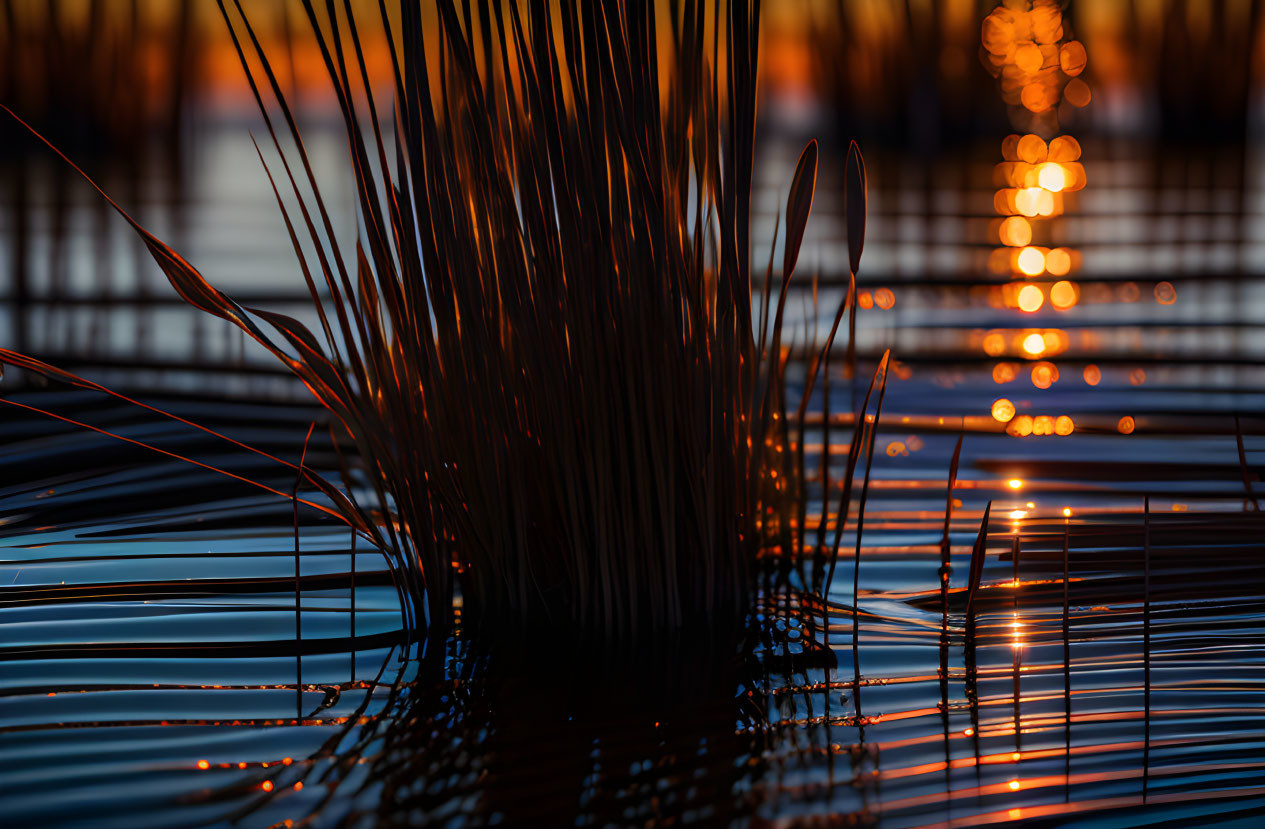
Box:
(0, 79, 1265, 826)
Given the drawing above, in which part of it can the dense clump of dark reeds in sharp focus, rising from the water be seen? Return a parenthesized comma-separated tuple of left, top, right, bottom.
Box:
(0, 0, 870, 642)
